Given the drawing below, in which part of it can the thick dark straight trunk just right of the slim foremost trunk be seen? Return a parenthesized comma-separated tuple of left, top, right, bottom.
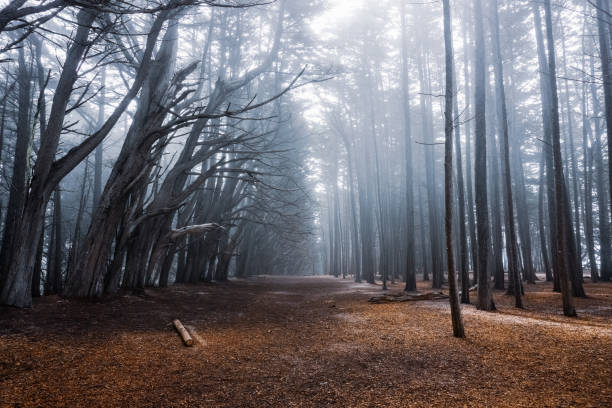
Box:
(474, 0, 495, 310)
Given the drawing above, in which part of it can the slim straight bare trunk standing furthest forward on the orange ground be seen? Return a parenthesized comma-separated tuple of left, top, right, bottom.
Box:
(442, 0, 465, 337)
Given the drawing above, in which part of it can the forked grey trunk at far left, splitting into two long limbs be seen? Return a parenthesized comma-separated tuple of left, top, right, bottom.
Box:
(0, 1, 173, 307)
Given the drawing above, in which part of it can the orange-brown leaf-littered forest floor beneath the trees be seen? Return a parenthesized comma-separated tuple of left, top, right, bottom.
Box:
(0, 277, 612, 408)
